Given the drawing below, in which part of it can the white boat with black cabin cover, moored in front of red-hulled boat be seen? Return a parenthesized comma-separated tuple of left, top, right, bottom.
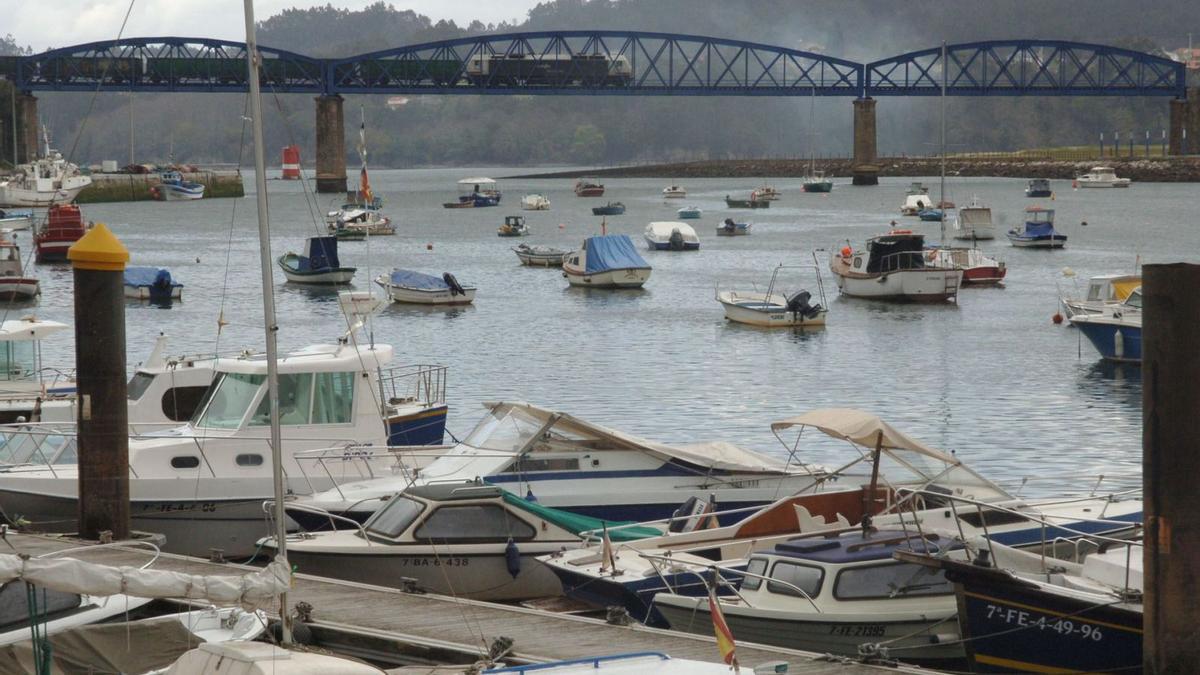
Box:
(829, 229, 962, 301)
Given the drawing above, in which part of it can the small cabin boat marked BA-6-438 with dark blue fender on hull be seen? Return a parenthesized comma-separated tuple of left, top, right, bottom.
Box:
(262, 482, 662, 601)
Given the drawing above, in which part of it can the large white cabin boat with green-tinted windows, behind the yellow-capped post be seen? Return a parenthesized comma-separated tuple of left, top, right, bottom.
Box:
(0, 319, 446, 556)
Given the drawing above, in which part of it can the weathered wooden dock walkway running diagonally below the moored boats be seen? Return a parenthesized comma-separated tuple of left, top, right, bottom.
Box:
(0, 533, 931, 675)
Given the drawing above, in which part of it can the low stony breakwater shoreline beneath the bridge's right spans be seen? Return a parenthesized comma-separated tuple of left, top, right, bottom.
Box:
(505, 156, 1200, 183)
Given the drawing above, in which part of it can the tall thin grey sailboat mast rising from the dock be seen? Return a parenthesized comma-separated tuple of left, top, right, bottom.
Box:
(242, 0, 292, 645)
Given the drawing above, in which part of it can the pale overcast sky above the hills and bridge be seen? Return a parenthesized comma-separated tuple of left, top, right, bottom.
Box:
(0, 0, 538, 52)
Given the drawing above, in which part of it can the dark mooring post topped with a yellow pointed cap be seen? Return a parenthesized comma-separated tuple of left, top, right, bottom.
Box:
(67, 223, 130, 539)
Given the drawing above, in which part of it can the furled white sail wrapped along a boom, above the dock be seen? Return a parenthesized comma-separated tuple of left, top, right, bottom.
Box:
(0, 554, 292, 609)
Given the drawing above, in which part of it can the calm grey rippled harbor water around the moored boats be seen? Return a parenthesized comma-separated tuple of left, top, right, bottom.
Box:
(16, 168, 1200, 492)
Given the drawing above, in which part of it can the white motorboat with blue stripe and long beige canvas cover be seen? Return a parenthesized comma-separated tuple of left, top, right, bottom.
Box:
(293, 402, 823, 522)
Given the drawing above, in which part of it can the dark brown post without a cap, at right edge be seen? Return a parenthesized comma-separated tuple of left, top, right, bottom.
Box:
(1141, 263, 1200, 674)
